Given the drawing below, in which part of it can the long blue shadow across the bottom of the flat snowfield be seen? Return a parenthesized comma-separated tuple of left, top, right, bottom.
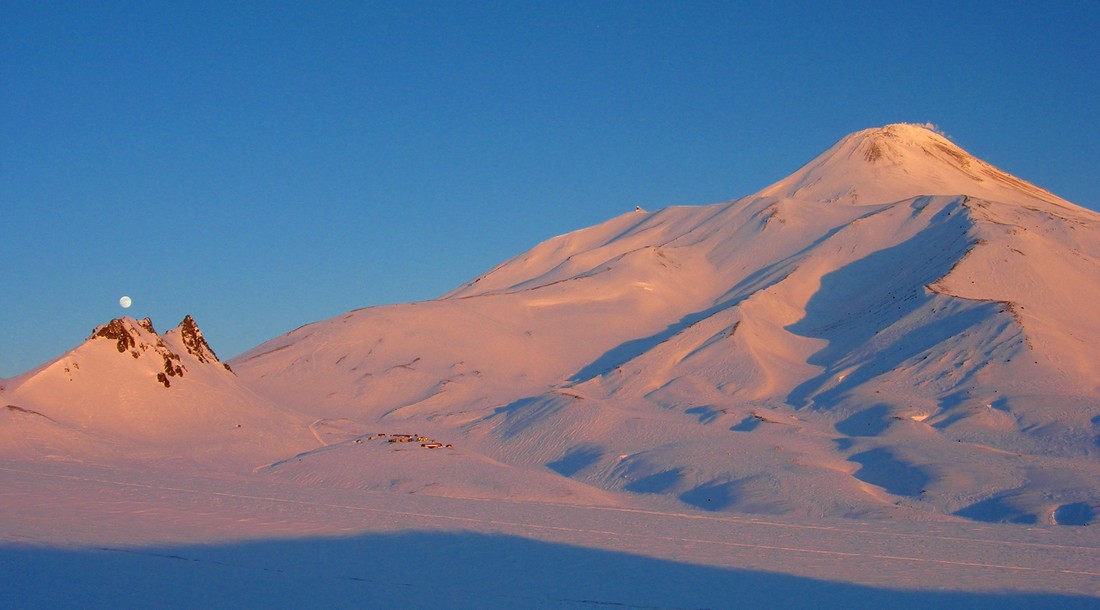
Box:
(0, 531, 1100, 609)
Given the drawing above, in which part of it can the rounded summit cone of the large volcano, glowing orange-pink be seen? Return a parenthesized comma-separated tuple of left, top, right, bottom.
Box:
(757, 123, 1076, 208)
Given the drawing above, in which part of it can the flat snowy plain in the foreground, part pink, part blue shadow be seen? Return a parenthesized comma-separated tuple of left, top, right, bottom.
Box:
(0, 464, 1100, 608)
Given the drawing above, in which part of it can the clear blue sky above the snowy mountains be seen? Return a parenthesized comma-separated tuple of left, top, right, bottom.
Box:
(0, 0, 1100, 377)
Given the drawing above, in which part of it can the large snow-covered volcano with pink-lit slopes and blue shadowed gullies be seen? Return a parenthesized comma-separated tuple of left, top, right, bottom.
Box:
(2, 124, 1100, 524)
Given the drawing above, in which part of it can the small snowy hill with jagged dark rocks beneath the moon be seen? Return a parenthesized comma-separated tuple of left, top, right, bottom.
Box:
(0, 315, 315, 463)
